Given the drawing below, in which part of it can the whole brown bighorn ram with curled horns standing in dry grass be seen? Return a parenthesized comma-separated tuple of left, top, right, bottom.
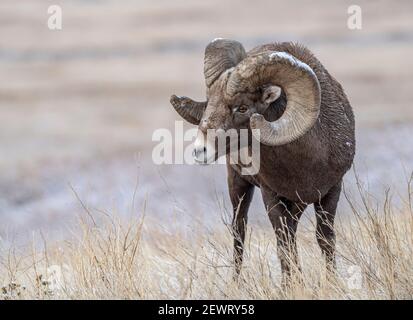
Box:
(171, 39, 355, 279)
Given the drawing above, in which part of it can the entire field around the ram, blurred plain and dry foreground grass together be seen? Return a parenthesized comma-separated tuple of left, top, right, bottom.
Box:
(0, 0, 413, 299)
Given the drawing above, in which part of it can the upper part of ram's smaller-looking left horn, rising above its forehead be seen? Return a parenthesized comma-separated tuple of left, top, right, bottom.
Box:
(204, 38, 247, 88)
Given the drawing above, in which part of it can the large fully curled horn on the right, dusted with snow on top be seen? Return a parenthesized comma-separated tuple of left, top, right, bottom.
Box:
(226, 52, 321, 146)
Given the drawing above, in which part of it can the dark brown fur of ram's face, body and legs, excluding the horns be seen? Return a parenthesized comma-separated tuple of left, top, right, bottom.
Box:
(171, 43, 355, 282)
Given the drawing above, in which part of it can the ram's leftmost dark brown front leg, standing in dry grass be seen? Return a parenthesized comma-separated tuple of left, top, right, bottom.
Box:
(228, 165, 254, 279)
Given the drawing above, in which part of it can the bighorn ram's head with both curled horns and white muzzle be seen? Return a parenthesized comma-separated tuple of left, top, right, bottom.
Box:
(171, 39, 321, 163)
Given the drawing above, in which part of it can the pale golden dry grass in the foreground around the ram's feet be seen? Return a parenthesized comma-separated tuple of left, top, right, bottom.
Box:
(0, 174, 413, 299)
